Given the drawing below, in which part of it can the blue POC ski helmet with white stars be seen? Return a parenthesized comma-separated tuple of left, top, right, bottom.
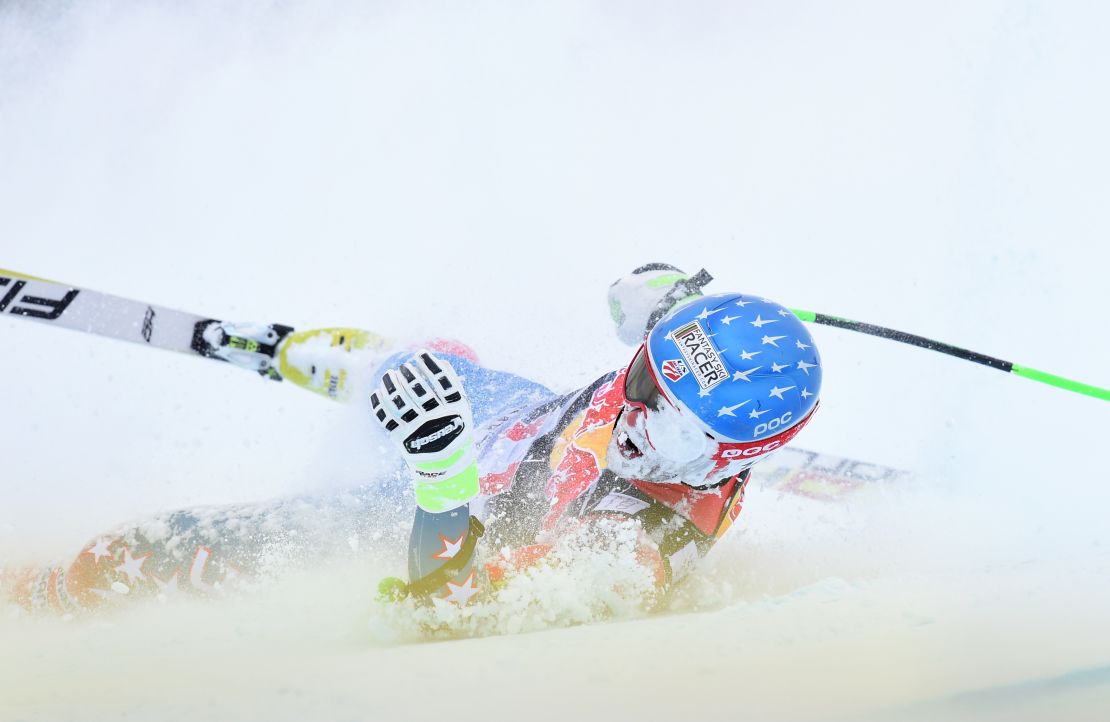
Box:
(645, 293, 821, 443)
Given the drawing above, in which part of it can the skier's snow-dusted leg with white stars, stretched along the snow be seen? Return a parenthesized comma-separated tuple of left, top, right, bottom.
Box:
(0, 488, 400, 614)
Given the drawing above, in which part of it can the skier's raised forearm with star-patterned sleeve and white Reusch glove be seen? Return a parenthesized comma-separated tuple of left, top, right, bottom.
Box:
(370, 351, 483, 604)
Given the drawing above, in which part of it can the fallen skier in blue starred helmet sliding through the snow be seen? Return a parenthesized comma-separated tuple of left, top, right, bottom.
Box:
(8, 263, 821, 613)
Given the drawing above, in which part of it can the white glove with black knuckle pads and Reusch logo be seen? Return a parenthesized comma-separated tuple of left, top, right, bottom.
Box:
(370, 351, 478, 513)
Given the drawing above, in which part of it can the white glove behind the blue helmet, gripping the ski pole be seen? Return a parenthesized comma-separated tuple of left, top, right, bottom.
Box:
(609, 263, 713, 345)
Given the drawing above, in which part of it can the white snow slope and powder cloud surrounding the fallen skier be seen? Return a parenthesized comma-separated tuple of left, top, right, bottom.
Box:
(0, 0, 1110, 721)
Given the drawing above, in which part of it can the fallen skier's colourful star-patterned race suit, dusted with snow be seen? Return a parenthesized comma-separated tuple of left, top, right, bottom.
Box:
(8, 344, 748, 614)
